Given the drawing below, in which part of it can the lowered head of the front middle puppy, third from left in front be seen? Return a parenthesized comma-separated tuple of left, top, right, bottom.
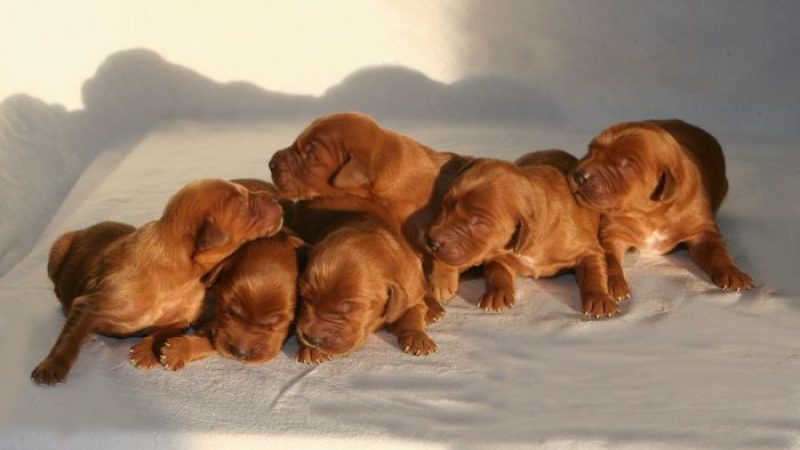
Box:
(297, 227, 424, 356)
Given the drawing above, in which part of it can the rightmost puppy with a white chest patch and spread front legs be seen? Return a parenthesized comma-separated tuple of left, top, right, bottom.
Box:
(570, 120, 753, 299)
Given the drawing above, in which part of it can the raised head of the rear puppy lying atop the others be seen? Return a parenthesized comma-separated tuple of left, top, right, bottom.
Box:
(269, 113, 385, 199)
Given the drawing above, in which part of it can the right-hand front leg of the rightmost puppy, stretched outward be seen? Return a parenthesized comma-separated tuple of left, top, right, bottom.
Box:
(687, 230, 753, 291)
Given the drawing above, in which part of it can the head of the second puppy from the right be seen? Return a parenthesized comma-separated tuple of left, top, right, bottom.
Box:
(426, 159, 535, 266)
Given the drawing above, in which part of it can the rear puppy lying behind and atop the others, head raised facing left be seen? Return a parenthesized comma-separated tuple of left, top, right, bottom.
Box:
(269, 113, 470, 306)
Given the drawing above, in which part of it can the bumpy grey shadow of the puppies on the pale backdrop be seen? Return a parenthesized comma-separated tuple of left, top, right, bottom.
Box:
(0, 49, 559, 275)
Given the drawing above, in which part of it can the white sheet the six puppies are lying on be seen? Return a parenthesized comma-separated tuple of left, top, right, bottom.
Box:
(0, 114, 800, 449)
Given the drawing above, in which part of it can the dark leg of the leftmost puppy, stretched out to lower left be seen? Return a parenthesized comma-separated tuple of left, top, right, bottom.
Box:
(31, 296, 96, 384)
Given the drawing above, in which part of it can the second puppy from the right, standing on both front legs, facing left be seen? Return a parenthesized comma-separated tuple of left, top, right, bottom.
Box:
(428, 150, 619, 317)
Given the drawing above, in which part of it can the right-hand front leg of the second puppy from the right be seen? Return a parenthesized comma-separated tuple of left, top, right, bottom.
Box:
(575, 254, 619, 319)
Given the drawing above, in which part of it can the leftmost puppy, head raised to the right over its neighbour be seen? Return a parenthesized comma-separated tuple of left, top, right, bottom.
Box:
(31, 180, 283, 384)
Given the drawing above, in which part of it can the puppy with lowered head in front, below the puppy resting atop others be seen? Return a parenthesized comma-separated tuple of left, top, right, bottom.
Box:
(292, 197, 436, 364)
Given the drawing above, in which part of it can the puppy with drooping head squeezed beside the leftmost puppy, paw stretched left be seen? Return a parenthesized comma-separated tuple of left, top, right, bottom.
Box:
(161, 228, 303, 370)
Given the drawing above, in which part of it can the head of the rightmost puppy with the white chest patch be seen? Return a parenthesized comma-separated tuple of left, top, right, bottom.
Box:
(568, 122, 680, 212)
